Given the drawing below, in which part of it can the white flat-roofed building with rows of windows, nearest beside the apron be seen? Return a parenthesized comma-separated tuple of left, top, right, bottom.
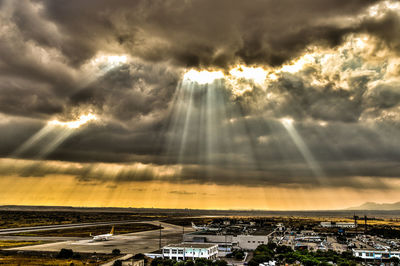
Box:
(162, 243, 218, 261)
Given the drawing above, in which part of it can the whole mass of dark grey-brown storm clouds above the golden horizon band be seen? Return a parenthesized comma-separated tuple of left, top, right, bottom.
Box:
(0, 0, 400, 190)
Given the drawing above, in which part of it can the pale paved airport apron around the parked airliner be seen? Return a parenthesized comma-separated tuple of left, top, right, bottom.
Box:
(8, 221, 193, 254)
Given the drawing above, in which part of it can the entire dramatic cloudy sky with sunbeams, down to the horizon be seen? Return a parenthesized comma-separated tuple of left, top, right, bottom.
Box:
(0, 0, 400, 210)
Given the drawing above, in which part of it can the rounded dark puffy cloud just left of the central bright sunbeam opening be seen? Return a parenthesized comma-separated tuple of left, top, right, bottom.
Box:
(70, 64, 178, 121)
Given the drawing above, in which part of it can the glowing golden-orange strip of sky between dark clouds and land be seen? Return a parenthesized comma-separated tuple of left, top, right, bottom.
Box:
(0, 175, 399, 210)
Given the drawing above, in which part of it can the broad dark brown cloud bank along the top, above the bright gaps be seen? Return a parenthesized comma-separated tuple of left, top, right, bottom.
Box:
(21, 0, 377, 66)
